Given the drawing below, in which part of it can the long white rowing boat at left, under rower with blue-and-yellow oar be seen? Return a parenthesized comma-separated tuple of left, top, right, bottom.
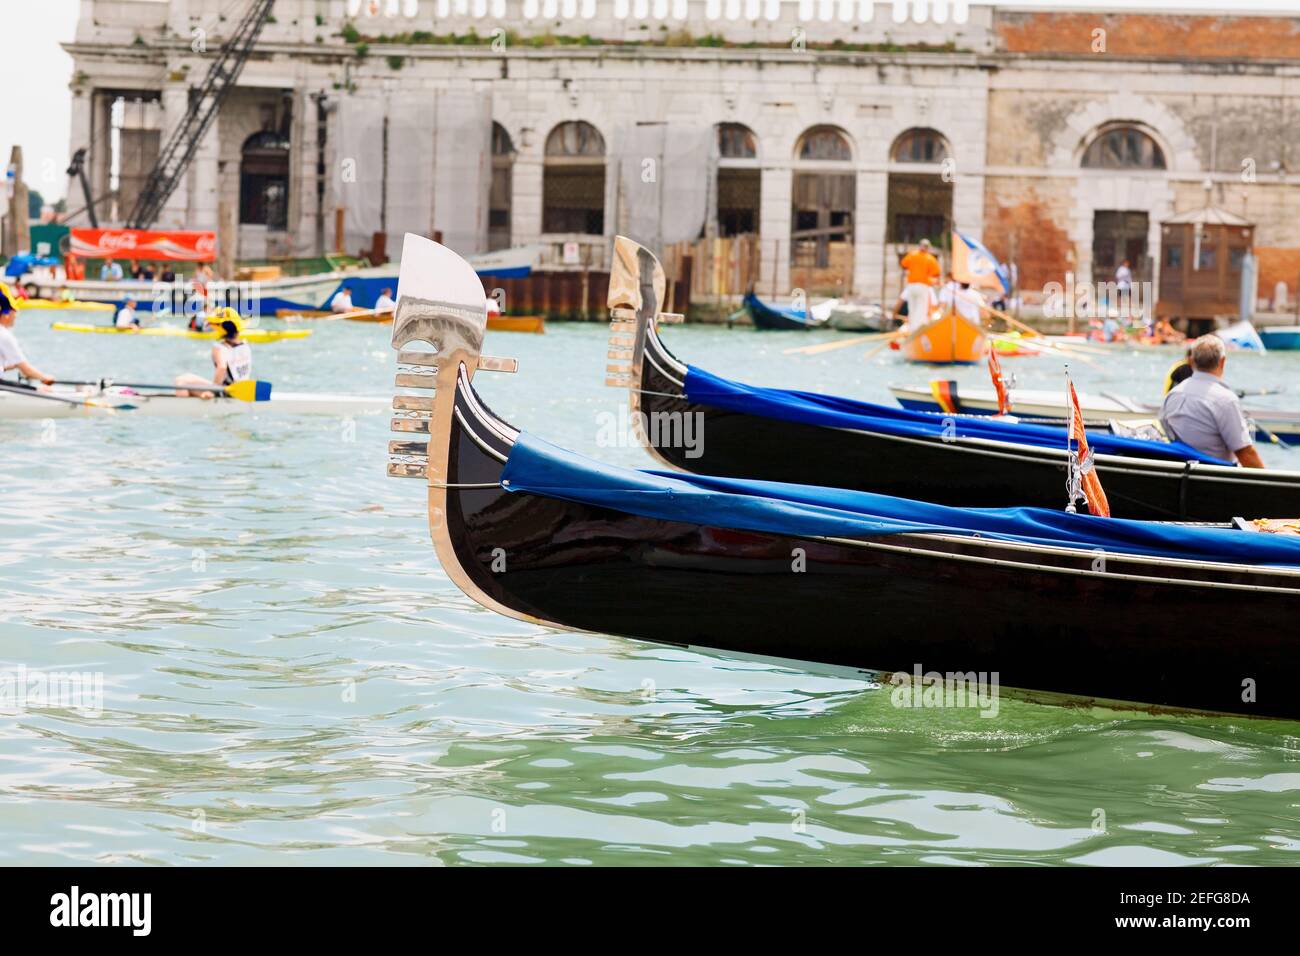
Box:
(0, 388, 391, 420)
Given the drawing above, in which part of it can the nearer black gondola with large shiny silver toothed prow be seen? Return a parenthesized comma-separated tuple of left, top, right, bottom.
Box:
(389, 235, 1300, 718)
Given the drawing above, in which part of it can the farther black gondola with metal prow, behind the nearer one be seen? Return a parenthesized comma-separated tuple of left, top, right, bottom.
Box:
(607, 237, 1300, 522)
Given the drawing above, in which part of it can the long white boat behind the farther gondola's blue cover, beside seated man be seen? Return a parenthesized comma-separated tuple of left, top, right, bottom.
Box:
(889, 382, 1300, 445)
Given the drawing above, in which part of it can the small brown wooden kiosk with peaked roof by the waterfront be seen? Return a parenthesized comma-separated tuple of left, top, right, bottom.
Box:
(1156, 206, 1255, 330)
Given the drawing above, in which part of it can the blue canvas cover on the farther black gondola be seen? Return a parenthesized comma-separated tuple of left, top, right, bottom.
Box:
(686, 365, 1232, 464)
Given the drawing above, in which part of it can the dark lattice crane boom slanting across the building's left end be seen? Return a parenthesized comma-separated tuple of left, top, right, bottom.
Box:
(126, 0, 276, 229)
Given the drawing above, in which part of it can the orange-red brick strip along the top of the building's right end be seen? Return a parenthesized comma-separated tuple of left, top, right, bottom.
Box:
(993, 10, 1300, 60)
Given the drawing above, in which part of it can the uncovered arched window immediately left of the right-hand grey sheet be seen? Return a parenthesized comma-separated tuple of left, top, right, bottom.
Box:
(542, 121, 605, 235)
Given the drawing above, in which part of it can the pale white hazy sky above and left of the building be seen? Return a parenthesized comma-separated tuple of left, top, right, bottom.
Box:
(10, 0, 1300, 207)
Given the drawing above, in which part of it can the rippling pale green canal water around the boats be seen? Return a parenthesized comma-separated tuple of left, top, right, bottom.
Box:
(0, 313, 1300, 865)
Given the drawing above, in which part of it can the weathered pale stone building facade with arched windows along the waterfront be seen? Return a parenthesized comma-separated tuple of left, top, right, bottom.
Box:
(68, 0, 1300, 303)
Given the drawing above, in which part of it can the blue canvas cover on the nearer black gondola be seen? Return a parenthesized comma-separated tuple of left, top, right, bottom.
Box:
(502, 432, 1300, 567)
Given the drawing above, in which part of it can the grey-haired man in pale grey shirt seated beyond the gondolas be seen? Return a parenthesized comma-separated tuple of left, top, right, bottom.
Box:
(1160, 336, 1264, 468)
